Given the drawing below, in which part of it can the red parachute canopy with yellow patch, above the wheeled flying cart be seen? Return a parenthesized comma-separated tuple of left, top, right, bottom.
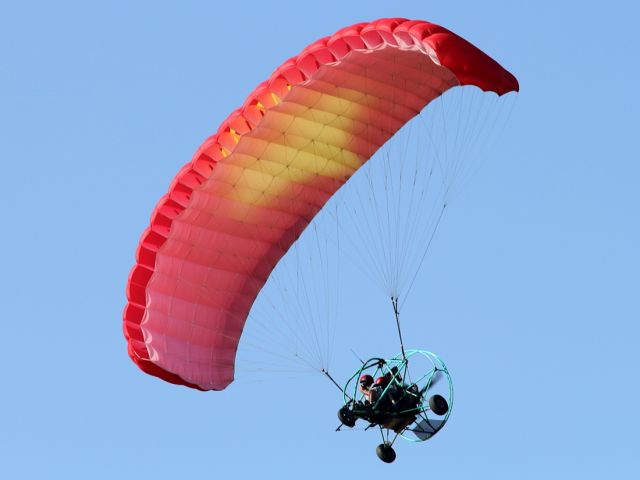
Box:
(124, 18, 518, 390)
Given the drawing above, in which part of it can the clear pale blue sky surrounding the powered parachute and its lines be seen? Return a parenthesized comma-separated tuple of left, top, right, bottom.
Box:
(0, 0, 640, 479)
